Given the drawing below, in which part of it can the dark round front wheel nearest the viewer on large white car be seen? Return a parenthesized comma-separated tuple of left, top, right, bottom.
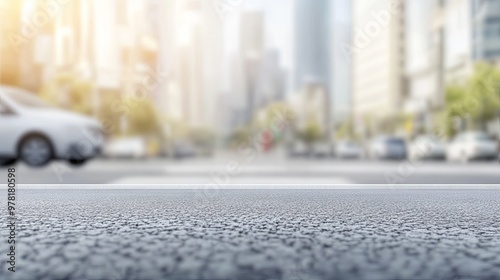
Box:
(19, 135, 52, 167)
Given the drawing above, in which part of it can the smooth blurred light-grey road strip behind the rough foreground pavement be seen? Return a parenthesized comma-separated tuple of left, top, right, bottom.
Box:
(0, 157, 500, 185)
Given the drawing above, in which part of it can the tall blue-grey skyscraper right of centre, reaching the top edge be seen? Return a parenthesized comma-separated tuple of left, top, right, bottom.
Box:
(293, 0, 332, 91)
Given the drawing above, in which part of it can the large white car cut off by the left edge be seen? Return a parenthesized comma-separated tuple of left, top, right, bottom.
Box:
(0, 87, 103, 167)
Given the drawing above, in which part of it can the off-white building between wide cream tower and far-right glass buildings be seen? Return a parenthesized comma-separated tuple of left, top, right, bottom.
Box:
(404, 0, 444, 132)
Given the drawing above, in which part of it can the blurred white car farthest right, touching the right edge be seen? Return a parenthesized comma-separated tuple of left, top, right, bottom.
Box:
(447, 132, 498, 162)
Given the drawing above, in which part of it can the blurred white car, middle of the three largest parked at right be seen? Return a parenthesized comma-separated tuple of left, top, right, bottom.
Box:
(408, 135, 446, 160)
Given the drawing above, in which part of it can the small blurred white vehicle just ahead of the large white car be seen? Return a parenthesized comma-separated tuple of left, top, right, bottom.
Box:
(103, 137, 148, 159)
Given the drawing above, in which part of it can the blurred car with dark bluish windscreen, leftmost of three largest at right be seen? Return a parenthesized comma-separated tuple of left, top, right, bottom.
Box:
(369, 136, 407, 160)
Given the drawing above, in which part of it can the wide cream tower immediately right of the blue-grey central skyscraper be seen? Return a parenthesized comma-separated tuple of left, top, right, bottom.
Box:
(349, 0, 405, 127)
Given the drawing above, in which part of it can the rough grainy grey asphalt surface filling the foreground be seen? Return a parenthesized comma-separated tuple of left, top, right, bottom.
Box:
(0, 190, 500, 280)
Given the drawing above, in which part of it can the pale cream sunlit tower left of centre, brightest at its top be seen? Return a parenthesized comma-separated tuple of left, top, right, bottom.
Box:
(174, 0, 224, 127)
